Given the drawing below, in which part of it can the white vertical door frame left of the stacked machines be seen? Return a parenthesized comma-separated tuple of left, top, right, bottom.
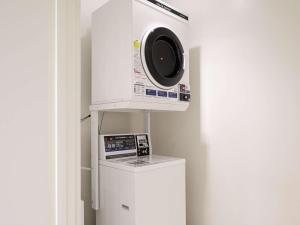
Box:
(48, 0, 82, 225)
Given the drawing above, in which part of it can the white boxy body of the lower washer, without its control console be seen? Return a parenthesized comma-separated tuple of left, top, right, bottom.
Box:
(97, 158, 186, 225)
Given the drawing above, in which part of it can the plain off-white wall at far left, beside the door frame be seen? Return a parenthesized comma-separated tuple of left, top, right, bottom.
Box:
(0, 0, 50, 225)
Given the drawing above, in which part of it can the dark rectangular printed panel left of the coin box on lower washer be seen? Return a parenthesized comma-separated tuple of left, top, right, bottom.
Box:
(104, 135, 136, 152)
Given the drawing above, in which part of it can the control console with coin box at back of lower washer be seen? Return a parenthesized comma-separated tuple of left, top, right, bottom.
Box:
(99, 133, 152, 159)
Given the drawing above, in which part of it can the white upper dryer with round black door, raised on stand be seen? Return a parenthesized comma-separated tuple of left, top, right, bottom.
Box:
(91, 0, 191, 111)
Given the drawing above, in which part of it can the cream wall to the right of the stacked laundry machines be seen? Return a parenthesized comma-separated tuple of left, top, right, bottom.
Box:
(152, 0, 300, 225)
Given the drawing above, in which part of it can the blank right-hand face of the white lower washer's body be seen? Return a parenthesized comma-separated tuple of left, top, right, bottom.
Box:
(135, 164, 186, 225)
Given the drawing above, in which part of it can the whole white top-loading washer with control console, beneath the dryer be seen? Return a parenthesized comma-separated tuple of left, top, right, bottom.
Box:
(97, 134, 186, 225)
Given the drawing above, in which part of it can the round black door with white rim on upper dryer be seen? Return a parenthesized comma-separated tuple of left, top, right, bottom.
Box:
(141, 27, 185, 89)
